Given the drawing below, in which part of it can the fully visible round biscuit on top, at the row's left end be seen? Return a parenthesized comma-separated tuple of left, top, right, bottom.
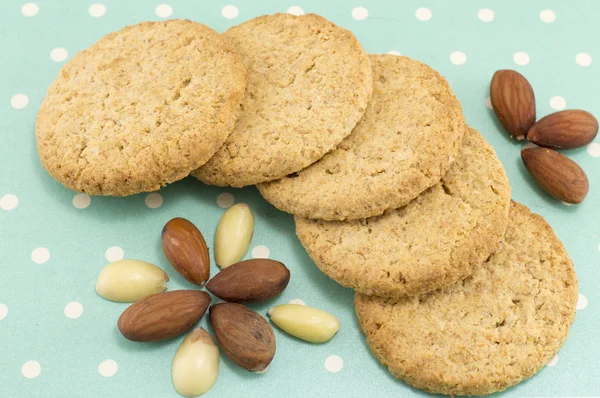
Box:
(37, 20, 246, 196)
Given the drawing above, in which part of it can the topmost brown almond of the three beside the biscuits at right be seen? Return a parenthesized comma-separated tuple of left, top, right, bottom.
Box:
(490, 69, 535, 140)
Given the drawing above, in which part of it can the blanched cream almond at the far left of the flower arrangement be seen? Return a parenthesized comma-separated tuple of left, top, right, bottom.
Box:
(96, 260, 169, 303)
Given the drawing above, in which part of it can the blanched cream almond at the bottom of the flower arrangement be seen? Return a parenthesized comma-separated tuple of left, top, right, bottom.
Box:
(171, 328, 219, 397)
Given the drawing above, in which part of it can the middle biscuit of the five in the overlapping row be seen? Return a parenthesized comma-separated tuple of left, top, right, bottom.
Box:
(258, 55, 465, 220)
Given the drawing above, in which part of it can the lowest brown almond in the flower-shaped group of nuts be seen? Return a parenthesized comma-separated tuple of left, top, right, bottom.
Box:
(209, 303, 275, 372)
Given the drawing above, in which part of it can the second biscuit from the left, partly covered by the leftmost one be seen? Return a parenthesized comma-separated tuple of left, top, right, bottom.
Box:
(193, 14, 373, 187)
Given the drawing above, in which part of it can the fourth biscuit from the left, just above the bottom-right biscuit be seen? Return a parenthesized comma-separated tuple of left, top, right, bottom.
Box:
(295, 128, 510, 297)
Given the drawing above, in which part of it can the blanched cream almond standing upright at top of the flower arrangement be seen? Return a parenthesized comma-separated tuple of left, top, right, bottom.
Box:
(215, 203, 254, 268)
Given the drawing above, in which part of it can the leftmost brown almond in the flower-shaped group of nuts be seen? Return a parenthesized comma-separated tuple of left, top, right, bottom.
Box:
(118, 290, 210, 341)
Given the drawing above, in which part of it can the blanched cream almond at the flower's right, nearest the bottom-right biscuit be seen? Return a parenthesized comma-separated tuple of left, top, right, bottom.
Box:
(268, 304, 340, 343)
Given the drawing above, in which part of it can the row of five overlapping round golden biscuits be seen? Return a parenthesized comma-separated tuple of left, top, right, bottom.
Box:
(37, 14, 577, 395)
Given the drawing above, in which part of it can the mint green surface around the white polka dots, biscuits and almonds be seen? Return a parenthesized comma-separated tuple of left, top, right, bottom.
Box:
(0, 0, 600, 398)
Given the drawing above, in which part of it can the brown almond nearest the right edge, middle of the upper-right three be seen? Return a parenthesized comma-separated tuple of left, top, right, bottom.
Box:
(527, 109, 598, 149)
